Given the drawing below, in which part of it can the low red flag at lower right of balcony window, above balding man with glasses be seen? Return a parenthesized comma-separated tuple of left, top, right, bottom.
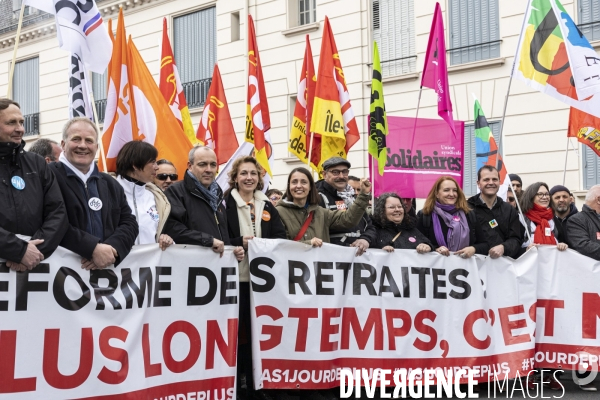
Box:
(196, 64, 239, 164)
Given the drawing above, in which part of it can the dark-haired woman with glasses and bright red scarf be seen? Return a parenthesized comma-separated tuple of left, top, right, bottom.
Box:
(520, 182, 569, 251)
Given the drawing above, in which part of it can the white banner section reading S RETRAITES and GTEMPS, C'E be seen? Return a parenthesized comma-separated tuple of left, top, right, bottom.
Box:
(249, 239, 537, 389)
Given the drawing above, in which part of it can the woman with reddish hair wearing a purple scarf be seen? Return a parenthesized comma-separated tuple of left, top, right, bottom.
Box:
(417, 176, 489, 258)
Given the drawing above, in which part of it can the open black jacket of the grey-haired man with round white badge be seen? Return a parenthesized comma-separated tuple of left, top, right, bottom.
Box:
(50, 162, 139, 266)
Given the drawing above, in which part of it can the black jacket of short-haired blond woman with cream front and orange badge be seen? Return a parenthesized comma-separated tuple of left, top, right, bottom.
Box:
(225, 195, 286, 246)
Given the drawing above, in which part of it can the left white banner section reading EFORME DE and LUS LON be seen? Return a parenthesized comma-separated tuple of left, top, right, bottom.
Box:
(0, 244, 238, 400)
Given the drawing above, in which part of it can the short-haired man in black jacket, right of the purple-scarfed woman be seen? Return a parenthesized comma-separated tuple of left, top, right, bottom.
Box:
(468, 165, 525, 258)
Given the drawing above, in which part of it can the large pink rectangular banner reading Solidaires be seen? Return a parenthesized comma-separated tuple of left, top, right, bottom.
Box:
(373, 115, 464, 198)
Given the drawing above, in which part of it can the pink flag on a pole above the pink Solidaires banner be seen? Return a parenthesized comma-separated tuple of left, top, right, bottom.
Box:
(421, 3, 456, 137)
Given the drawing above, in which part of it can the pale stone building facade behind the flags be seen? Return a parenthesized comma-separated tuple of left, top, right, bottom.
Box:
(0, 0, 600, 197)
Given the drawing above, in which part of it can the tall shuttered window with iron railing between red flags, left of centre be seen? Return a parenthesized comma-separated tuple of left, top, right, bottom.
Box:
(173, 7, 217, 108)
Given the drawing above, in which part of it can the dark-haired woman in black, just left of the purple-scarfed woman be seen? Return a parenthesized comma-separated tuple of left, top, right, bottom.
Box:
(372, 193, 432, 253)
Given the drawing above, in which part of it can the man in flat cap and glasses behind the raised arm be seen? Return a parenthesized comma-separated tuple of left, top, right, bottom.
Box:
(316, 157, 376, 255)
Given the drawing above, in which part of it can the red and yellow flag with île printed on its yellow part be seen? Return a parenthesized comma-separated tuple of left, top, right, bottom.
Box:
(310, 17, 360, 164)
